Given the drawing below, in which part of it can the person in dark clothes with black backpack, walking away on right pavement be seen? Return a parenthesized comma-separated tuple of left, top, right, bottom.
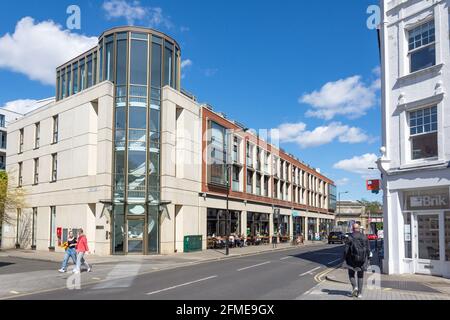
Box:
(344, 223, 372, 298)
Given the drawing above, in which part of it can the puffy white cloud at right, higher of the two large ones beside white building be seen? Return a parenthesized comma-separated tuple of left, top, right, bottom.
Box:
(299, 76, 379, 120)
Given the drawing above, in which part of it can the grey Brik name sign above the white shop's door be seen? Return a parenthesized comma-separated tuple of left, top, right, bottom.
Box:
(405, 188, 450, 210)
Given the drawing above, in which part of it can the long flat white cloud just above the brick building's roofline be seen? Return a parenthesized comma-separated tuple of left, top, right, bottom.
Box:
(271, 122, 370, 148)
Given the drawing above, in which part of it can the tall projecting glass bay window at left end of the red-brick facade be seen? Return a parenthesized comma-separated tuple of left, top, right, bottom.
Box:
(208, 121, 227, 186)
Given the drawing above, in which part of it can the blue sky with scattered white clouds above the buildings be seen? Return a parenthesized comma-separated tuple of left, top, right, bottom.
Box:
(0, 0, 381, 200)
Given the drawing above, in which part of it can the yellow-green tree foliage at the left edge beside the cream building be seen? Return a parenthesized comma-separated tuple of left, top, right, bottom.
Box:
(0, 171, 25, 225)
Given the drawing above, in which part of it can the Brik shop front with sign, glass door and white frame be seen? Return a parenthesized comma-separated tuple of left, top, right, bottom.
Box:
(403, 187, 450, 277)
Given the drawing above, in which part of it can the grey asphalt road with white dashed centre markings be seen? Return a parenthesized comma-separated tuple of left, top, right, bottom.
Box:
(0, 245, 343, 300)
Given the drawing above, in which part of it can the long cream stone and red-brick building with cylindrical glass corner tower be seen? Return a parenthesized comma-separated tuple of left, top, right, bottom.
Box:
(2, 27, 336, 255)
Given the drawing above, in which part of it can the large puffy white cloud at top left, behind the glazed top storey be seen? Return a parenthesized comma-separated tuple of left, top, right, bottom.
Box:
(0, 17, 98, 85)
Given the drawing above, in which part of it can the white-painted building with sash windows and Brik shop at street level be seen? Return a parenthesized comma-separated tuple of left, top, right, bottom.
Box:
(378, 0, 450, 277)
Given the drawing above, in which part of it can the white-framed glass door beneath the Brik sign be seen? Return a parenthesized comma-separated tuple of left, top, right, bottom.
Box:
(414, 214, 443, 275)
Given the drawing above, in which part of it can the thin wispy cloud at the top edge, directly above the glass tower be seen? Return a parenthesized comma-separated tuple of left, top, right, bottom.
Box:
(102, 0, 173, 29)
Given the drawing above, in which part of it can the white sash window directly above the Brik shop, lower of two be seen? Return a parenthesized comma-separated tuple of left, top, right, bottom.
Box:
(409, 106, 438, 160)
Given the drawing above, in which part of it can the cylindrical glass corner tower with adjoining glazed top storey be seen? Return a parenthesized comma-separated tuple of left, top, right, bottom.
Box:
(56, 27, 180, 254)
